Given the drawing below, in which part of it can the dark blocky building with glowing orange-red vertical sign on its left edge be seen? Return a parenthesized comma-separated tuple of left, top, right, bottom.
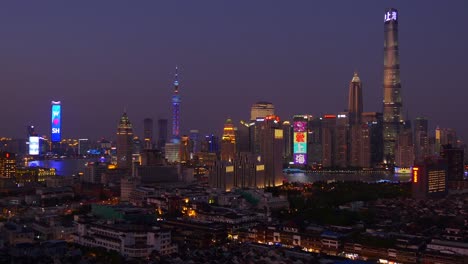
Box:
(411, 158, 447, 199)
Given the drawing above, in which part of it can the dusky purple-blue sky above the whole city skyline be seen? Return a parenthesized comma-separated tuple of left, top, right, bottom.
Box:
(0, 0, 468, 140)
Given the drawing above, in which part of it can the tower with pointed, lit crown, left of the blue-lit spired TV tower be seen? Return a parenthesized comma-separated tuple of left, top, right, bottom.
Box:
(116, 112, 133, 169)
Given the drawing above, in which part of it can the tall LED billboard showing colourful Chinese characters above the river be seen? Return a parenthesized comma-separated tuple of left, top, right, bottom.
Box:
(293, 119, 307, 165)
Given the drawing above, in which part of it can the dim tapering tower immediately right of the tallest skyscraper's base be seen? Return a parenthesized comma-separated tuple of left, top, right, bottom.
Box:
(395, 121, 414, 168)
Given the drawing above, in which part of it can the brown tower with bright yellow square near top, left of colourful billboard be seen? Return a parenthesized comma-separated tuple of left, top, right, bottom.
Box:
(256, 115, 284, 186)
